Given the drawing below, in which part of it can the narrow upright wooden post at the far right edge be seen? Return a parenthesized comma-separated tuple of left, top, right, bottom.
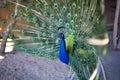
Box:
(113, 0, 120, 49)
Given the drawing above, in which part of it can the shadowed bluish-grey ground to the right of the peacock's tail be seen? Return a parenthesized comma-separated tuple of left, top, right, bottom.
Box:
(103, 47, 120, 80)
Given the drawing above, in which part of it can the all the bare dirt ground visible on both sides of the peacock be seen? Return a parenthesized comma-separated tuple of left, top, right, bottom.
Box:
(0, 41, 120, 80)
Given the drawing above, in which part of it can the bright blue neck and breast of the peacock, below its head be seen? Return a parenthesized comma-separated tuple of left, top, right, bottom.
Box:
(59, 39, 69, 64)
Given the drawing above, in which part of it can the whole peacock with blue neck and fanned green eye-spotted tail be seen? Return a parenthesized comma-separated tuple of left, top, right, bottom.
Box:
(0, 0, 108, 80)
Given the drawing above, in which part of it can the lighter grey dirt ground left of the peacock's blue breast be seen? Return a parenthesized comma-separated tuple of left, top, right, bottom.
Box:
(0, 51, 69, 80)
